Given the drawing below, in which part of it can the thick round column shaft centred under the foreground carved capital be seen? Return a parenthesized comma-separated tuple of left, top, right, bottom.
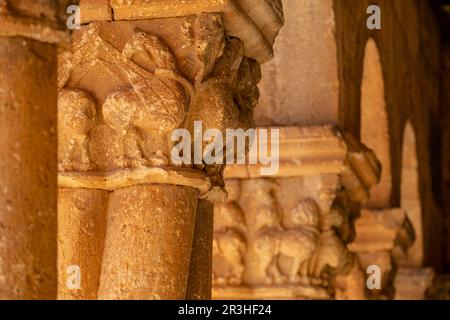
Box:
(98, 185, 198, 300)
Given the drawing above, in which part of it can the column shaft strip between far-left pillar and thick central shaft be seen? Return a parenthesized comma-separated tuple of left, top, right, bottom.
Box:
(58, 188, 109, 300)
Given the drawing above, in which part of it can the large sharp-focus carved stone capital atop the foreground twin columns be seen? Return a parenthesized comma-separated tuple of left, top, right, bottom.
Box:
(58, 13, 260, 193)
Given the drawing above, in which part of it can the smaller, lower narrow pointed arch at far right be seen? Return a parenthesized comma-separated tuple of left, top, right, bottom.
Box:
(400, 121, 424, 266)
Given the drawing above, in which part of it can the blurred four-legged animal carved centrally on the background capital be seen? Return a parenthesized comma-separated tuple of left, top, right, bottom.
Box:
(255, 199, 319, 284)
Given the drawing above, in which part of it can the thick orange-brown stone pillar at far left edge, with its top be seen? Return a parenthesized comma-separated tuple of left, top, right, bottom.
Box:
(0, 0, 66, 299)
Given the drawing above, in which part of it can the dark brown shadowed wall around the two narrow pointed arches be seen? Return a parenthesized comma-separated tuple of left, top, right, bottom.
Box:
(334, 0, 443, 267)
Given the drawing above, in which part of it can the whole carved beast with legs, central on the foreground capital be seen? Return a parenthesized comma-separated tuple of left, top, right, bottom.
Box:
(102, 31, 192, 167)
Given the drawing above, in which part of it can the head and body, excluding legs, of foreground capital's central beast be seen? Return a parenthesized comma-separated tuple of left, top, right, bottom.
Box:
(102, 31, 193, 132)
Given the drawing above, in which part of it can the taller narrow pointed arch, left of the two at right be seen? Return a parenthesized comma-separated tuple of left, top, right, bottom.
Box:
(360, 38, 392, 209)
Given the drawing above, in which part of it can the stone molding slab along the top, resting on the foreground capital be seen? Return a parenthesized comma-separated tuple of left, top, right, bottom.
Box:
(80, 0, 284, 63)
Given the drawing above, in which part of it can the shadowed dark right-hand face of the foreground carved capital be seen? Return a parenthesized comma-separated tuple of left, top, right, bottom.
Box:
(187, 38, 261, 186)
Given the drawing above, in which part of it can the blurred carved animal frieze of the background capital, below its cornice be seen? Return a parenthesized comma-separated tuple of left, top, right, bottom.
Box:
(213, 177, 355, 298)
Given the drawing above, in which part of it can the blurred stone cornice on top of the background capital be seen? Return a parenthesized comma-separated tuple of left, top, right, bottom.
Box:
(224, 126, 381, 202)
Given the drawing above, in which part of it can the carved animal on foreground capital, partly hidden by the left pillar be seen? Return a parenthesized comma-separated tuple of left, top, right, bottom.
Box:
(58, 89, 96, 171)
